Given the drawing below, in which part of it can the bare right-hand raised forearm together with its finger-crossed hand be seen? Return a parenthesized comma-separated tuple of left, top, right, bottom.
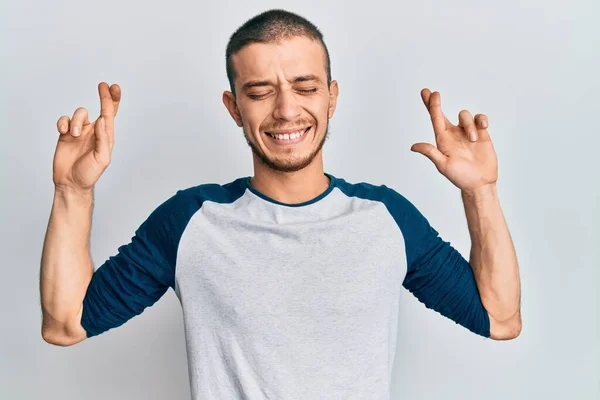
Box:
(411, 89, 521, 340)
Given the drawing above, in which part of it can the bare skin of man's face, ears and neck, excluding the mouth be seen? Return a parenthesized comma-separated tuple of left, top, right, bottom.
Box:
(223, 37, 339, 203)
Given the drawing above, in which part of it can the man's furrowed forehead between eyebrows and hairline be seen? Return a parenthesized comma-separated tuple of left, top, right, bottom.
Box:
(232, 36, 327, 85)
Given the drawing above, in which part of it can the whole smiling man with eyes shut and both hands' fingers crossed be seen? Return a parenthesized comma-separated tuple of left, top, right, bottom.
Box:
(41, 10, 521, 399)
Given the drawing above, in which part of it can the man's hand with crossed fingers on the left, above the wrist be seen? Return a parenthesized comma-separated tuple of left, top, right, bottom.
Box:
(53, 82, 121, 193)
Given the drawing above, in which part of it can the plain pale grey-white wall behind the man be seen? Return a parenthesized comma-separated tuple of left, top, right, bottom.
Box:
(0, 0, 600, 400)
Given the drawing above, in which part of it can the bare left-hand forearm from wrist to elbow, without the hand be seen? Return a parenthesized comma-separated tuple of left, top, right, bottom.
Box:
(40, 189, 94, 344)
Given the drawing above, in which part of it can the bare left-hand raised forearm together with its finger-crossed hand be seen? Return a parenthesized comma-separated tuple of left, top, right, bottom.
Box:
(40, 82, 121, 346)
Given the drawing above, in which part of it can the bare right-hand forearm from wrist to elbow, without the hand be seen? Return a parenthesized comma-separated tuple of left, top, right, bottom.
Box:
(462, 185, 521, 323)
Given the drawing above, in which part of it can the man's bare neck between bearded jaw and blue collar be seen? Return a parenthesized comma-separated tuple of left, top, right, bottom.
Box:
(250, 152, 329, 204)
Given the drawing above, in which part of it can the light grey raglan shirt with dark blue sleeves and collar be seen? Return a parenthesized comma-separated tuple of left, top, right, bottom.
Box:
(81, 174, 489, 400)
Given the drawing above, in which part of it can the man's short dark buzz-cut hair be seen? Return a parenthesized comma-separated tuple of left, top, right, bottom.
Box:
(225, 9, 331, 95)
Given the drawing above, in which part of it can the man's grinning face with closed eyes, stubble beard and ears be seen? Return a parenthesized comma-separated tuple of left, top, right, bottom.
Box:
(223, 37, 338, 172)
